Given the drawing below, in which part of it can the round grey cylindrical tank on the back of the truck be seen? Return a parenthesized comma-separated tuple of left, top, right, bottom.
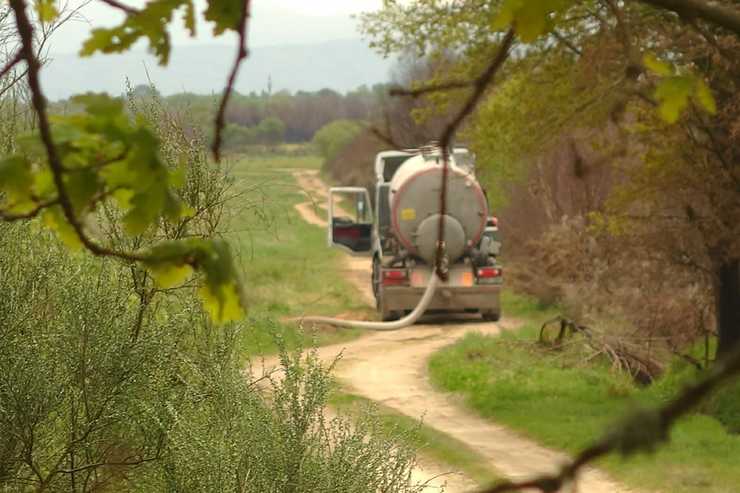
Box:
(388, 155, 488, 263)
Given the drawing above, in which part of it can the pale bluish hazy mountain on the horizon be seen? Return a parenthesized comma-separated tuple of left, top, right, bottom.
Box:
(43, 39, 392, 100)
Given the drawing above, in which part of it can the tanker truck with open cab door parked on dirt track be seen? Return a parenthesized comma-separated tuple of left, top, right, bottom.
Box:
(328, 146, 503, 321)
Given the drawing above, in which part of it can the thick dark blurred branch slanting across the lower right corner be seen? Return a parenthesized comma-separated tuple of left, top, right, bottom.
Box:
(481, 346, 740, 493)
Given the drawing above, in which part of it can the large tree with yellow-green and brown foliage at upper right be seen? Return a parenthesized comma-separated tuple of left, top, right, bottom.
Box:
(364, 0, 740, 353)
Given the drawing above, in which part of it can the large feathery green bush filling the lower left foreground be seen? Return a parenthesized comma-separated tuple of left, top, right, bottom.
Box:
(0, 224, 419, 492)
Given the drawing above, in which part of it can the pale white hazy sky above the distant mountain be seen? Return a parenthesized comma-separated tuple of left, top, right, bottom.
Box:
(52, 0, 382, 53)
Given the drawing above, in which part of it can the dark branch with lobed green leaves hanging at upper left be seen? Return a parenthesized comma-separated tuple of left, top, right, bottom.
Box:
(0, 0, 246, 322)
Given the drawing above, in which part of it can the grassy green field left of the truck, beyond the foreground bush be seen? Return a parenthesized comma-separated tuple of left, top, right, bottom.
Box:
(225, 156, 364, 354)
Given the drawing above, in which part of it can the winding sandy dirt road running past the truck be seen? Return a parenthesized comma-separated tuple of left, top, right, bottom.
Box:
(284, 171, 629, 493)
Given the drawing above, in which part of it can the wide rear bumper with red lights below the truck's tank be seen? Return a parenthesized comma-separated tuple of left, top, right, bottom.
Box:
(382, 285, 501, 313)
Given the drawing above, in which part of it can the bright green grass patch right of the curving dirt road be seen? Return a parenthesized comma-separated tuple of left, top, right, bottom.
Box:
(429, 290, 740, 493)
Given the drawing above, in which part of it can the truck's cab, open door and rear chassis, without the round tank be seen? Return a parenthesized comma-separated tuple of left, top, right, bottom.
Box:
(328, 147, 503, 320)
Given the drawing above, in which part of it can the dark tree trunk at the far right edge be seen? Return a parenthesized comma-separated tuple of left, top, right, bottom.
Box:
(715, 259, 740, 357)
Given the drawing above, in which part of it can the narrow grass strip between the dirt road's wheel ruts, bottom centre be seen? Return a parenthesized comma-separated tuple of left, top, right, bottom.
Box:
(329, 390, 501, 485)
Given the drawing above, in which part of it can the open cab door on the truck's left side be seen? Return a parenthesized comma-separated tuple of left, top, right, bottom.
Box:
(328, 187, 373, 256)
